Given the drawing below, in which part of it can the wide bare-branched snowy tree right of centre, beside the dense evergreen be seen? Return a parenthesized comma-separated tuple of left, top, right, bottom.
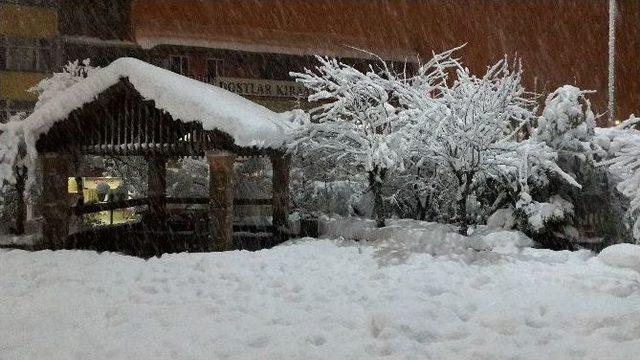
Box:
(401, 59, 575, 233)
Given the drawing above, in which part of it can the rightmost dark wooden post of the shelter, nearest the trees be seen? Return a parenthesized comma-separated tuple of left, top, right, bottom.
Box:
(271, 155, 291, 243)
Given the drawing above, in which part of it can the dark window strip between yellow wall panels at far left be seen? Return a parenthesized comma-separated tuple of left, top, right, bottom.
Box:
(0, 37, 51, 72)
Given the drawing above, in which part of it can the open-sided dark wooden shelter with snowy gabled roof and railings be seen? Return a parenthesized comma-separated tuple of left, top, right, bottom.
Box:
(25, 59, 290, 251)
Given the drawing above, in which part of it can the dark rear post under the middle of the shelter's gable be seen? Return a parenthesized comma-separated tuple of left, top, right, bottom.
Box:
(147, 156, 167, 225)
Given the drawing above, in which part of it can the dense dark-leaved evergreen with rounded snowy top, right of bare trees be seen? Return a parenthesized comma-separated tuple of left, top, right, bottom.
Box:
(516, 85, 628, 249)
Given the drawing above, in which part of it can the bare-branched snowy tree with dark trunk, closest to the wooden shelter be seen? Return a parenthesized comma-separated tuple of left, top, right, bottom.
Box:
(291, 56, 404, 226)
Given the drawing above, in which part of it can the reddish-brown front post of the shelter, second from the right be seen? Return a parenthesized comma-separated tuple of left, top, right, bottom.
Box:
(206, 151, 236, 251)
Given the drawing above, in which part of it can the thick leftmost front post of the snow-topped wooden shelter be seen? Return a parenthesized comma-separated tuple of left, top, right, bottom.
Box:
(40, 153, 73, 249)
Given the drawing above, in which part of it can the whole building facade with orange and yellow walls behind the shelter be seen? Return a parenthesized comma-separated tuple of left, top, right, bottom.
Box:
(0, 0, 640, 125)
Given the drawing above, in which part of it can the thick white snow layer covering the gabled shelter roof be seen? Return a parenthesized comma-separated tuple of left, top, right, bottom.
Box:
(24, 58, 297, 148)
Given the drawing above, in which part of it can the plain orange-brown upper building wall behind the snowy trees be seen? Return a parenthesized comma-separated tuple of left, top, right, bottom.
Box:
(132, 0, 640, 122)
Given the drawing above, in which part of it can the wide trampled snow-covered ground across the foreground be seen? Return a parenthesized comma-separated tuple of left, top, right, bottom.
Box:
(0, 240, 640, 360)
